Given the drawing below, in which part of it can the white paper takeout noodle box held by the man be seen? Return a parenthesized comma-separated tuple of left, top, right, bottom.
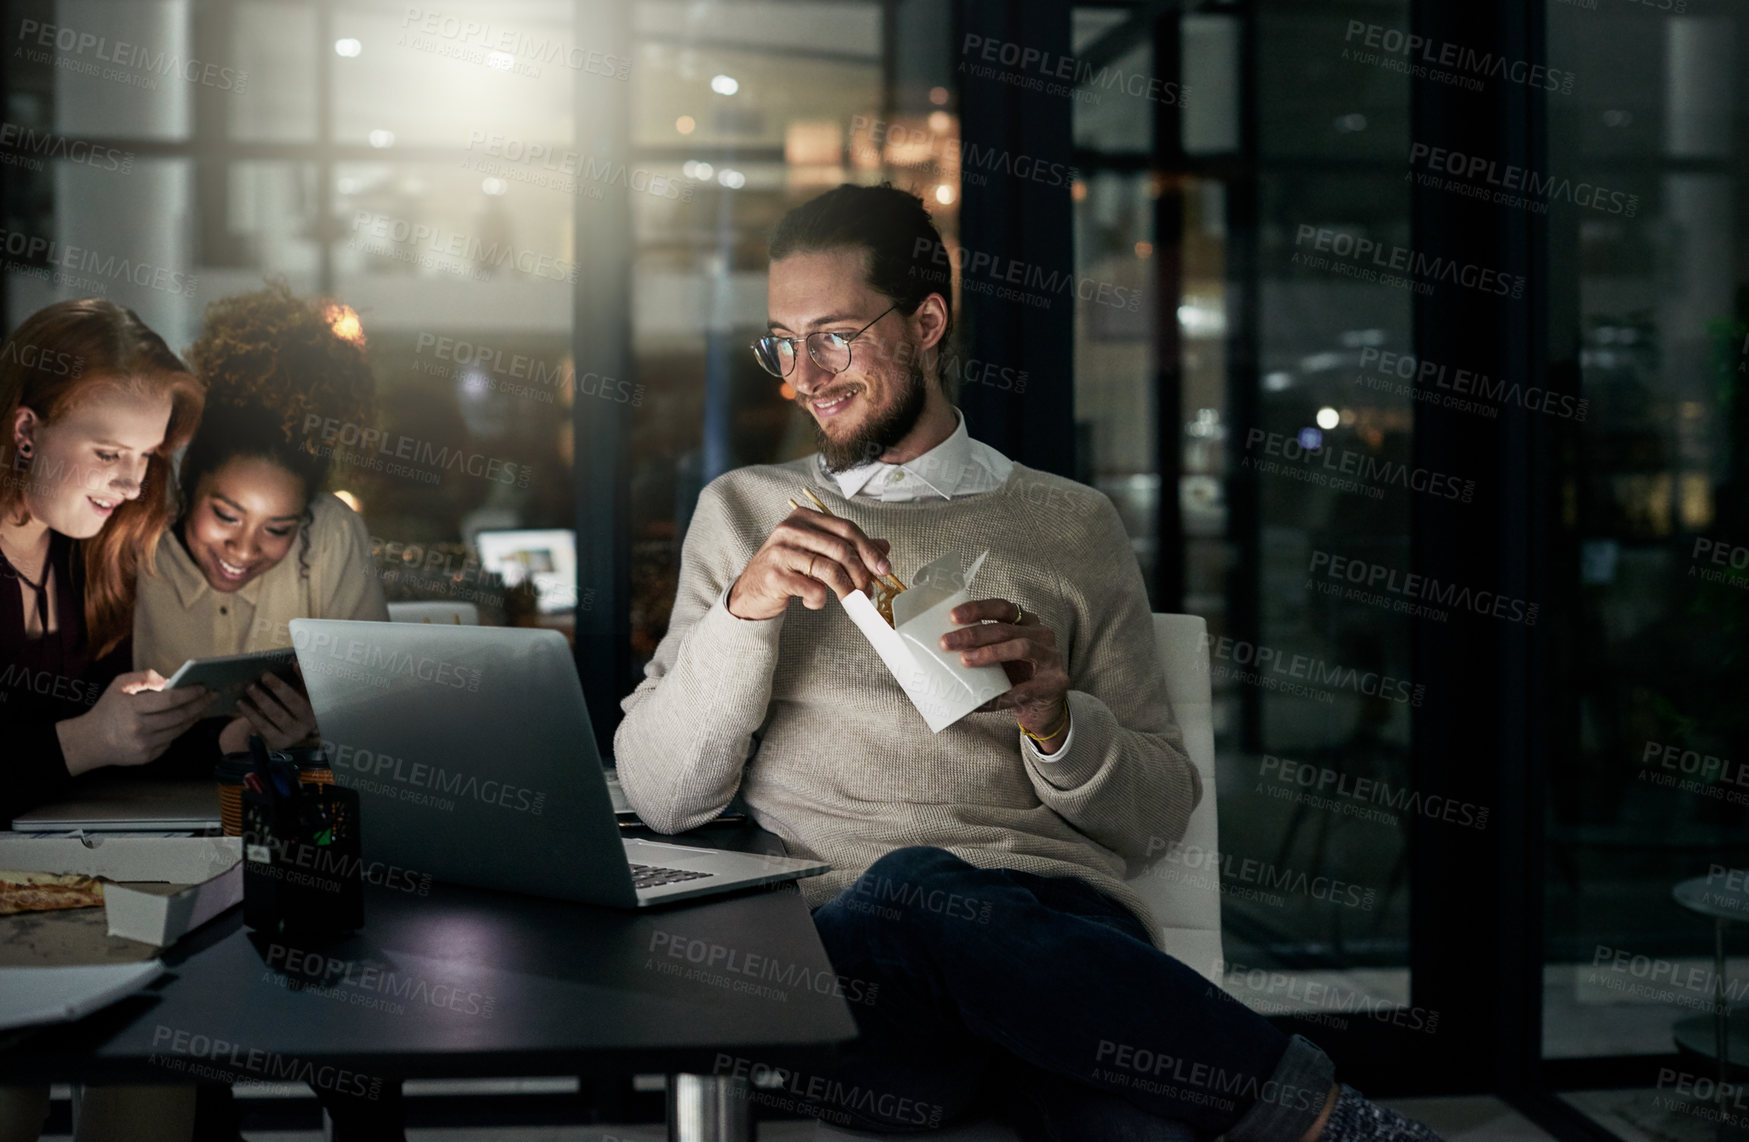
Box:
(840, 551, 1013, 733)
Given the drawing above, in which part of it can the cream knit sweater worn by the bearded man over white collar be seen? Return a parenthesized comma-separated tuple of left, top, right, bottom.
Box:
(614, 458, 1202, 944)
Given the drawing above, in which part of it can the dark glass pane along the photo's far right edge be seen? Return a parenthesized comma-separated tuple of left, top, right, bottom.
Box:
(1541, 3, 1749, 1137)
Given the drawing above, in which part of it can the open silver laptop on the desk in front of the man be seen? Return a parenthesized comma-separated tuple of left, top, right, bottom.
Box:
(290, 619, 829, 908)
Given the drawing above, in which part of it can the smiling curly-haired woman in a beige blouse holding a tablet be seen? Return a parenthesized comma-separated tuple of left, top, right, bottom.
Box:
(133, 282, 388, 752)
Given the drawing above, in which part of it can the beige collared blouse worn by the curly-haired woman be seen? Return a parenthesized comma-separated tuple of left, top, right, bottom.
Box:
(133, 491, 388, 677)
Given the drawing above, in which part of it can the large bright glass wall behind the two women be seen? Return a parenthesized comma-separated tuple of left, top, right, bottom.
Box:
(3, 0, 587, 628)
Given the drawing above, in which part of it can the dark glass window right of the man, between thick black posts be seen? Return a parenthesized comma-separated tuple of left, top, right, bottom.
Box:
(1074, 5, 1417, 1020)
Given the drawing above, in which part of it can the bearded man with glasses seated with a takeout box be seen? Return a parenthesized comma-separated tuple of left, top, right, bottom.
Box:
(614, 185, 1434, 1142)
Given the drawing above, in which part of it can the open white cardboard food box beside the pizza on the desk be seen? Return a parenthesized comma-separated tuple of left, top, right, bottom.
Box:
(0, 832, 243, 948)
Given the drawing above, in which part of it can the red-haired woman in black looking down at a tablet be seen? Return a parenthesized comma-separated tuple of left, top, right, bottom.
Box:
(0, 299, 206, 820)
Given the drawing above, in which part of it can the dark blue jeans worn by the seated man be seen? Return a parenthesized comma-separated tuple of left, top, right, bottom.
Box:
(791, 846, 1334, 1142)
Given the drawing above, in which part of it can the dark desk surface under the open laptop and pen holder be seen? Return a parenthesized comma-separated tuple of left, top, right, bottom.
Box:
(0, 832, 855, 1086)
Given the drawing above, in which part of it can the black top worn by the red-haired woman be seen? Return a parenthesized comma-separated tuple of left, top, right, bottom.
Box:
(0, 530, 224, 822)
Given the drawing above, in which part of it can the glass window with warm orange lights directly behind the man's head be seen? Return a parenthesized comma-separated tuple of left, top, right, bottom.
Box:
(619, 0, 958, 673)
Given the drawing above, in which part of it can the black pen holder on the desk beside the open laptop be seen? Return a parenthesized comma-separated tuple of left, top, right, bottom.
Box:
(241, 785, 364, 936)
